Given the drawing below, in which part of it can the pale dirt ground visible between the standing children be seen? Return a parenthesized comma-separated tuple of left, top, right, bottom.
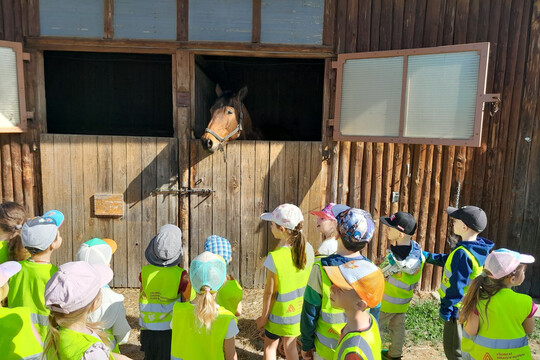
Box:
(115, 289, 540, 360)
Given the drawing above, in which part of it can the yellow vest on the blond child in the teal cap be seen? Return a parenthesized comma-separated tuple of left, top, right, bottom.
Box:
(171, 302, 236, 360)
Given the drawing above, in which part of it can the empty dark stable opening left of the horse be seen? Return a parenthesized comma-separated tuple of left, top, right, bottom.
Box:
(44, 51, 174, 137)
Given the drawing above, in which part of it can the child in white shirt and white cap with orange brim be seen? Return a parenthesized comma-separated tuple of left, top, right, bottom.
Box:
(77, 238, 131, 353)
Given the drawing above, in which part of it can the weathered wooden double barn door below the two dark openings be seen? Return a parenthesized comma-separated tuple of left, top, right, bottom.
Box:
(40, 134, 324, 287)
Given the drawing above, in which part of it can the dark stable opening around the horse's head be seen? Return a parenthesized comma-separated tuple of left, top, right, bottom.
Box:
(192, 55, 324, 141)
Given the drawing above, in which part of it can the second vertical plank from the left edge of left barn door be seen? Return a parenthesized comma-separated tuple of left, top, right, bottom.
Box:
(52, 135, 72, 265)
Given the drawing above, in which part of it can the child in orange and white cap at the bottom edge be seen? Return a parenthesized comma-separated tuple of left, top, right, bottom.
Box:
(324, 260, 384, 360)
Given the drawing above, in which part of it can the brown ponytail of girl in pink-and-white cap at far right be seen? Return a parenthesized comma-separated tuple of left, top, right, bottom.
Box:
(459, 264, 526, 324)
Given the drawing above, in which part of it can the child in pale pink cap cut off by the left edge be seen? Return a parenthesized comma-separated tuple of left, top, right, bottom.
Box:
(0, 261, 42, 360)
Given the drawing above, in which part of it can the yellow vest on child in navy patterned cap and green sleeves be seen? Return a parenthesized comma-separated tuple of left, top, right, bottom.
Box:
(313, 261, 347, 359)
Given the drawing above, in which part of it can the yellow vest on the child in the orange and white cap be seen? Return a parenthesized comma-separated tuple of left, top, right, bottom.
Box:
(334, 315, 381, 360)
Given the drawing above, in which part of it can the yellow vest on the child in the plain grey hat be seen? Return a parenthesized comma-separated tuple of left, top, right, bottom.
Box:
(139, 265, 184, 331)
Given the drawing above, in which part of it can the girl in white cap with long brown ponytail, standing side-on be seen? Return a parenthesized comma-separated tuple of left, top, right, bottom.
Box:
(257, 204, 315, 360)
